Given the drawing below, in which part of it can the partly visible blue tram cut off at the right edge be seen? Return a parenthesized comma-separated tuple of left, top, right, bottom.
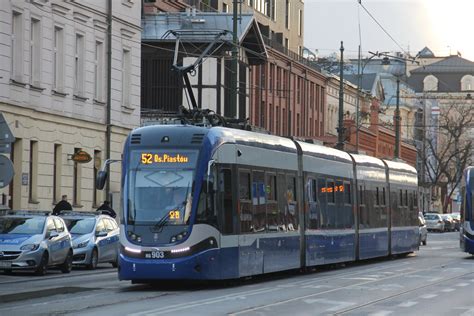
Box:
(459, 166, 474, 255)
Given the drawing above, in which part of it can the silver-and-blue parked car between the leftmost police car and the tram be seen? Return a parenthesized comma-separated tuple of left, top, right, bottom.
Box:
(61, 211, 120, 269)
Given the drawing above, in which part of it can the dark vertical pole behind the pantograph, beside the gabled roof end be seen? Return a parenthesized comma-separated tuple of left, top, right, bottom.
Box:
(228, 0, 239, 118)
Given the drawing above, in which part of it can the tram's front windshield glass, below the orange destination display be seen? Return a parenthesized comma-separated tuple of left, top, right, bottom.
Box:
(128, 168, 193, 225)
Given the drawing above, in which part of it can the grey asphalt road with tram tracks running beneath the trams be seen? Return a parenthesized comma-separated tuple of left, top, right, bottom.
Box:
(0, 232, 474, 316)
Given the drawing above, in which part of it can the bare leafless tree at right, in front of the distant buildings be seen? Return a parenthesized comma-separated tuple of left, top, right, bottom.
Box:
(419, 102, 474, 213)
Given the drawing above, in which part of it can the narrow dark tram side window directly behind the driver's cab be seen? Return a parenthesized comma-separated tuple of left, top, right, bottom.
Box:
(217, 168, 234, 234)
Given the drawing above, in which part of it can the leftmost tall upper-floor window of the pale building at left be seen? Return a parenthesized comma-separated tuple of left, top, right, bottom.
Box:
(11, 12, 23, 82)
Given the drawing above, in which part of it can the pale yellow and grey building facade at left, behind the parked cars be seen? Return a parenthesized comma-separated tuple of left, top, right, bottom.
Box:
(0, 0, 141, 210)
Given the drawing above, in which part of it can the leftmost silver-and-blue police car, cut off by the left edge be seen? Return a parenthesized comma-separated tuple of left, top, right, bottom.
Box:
(0, 211, 72, 275)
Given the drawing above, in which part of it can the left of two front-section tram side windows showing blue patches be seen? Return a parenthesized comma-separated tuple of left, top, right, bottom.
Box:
(252, 171, 267, 232)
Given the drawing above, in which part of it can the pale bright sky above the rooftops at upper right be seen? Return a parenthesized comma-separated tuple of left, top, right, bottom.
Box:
(304, 0, 474, 61)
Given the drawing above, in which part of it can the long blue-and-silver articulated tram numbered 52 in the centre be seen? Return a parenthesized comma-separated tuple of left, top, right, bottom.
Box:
(115, 125, 419, 282)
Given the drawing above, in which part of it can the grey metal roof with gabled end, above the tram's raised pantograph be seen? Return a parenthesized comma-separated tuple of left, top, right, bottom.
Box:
(142, 12, 268, 65)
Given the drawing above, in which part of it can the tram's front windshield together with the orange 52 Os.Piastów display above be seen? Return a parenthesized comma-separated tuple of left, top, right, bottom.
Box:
(127, 152, 196, 226)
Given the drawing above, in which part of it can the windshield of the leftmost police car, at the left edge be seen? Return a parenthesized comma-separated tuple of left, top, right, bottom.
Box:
(0, 217, 45, 235)
